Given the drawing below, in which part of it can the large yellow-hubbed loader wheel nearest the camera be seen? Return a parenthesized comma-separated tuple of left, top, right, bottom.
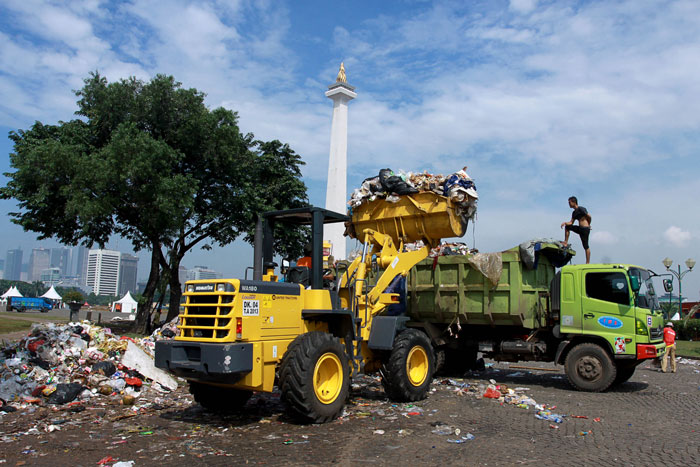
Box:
(279, 331, 350, 423)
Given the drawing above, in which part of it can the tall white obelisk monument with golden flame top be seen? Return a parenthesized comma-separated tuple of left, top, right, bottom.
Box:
(323, 63, 357, 260)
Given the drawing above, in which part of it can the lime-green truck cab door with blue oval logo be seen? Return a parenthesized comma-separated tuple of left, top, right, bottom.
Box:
(581, 270, 636, 354)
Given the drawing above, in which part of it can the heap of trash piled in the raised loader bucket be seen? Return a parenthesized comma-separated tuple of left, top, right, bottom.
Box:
(348, 167, 479, 223)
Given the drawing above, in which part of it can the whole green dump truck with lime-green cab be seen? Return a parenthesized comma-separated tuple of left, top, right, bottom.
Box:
(406, 242, 665, 392)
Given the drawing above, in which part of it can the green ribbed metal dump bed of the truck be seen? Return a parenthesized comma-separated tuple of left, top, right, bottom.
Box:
(406, 243, 573, 329)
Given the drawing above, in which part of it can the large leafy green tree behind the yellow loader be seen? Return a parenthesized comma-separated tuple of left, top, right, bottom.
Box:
(0, 73, 308, 332)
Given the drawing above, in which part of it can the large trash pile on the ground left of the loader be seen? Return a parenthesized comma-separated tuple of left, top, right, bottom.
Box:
(0, 321, 178, 413)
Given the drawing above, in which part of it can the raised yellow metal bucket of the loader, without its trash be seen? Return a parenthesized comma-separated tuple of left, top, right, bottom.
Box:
(349, 192, 467, 247)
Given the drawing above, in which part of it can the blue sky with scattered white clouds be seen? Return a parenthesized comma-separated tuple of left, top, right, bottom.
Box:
(0, 0, 700, 300)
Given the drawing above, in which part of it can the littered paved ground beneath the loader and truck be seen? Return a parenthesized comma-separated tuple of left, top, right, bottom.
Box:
(0, 356, 700, 466)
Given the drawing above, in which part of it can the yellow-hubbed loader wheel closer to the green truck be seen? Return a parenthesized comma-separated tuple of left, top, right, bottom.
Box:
(381, 329, 435, 402)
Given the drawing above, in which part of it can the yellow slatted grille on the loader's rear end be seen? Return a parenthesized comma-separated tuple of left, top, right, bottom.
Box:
(179, 292, 235, 340)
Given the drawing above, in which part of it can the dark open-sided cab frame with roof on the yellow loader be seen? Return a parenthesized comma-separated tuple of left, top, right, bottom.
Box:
(253, 206, 350, 289)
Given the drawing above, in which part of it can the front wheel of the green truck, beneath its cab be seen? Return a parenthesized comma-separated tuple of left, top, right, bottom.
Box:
(564, 343, 616, 392)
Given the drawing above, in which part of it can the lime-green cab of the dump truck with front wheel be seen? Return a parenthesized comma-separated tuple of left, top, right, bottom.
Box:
(552, 264, 665, 390)
